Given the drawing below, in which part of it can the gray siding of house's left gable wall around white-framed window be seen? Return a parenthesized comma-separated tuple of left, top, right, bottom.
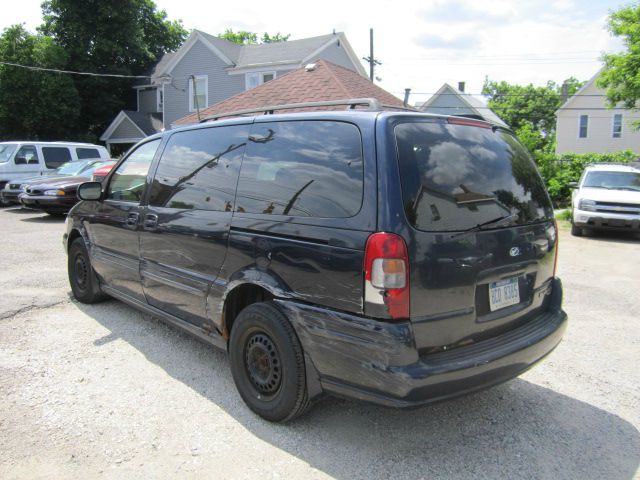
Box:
(164, 41, 244, 128)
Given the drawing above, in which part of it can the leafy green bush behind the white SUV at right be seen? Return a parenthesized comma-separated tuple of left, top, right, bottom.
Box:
(533, 150, 638, 207)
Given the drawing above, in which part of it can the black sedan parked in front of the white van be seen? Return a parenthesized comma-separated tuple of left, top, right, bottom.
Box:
(18, 160, 115, 215)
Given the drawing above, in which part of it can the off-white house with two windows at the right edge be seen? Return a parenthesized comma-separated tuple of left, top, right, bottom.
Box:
(556, 71, 640, 153)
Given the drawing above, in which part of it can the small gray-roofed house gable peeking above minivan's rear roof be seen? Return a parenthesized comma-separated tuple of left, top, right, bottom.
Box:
(416, 82, 507, 127)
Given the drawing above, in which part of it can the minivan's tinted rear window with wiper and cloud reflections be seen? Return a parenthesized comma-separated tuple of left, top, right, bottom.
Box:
(395, 121, 553, 232)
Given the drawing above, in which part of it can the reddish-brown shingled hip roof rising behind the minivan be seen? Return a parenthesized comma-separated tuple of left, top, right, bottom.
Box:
(174, 60, 403, 125)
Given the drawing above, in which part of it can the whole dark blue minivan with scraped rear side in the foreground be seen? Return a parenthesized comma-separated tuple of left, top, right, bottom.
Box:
(63, 100, 567, 421)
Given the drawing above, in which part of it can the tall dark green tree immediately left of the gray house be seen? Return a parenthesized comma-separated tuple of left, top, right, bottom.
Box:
(40, 0, 187, 140)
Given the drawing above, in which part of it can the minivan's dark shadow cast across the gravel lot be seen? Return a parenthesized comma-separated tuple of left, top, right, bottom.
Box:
(75, 300, 640, 480)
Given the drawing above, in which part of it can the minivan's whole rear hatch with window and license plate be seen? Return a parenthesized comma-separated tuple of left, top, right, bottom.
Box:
(393, 116, 556, 352)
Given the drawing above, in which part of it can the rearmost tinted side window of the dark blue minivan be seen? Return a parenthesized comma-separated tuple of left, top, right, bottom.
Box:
(236, 121, 364, 218)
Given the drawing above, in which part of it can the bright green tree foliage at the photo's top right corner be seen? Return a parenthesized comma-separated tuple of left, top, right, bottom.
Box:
(596, 4, 640, 108)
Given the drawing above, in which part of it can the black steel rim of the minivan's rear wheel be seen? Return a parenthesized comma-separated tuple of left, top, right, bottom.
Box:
(245, 333, 282, 395)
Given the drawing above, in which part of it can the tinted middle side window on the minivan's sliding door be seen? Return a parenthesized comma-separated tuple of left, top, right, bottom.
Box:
(149, 125, 249, 212)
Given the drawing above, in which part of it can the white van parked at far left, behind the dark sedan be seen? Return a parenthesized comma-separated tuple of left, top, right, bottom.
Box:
(0, 141, 109, 203)
